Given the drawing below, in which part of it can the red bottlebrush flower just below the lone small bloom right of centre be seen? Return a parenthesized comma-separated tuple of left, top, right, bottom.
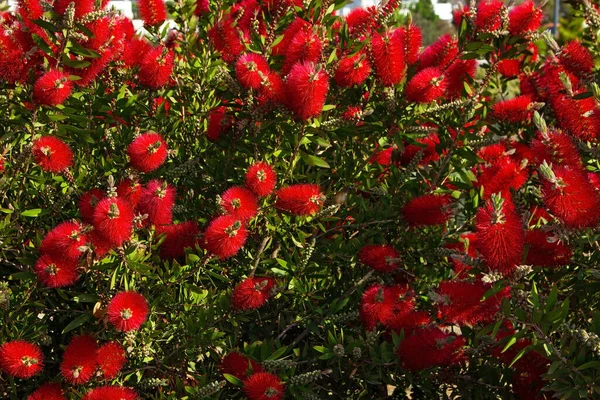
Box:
(360, 284, 415, 331)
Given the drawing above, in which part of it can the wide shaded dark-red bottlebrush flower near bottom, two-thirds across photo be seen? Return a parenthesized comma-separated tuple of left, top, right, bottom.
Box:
(396, 327, 465, 371)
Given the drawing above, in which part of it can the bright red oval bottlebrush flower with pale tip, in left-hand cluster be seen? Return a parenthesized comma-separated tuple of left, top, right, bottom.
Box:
(94, 197, 133, 246)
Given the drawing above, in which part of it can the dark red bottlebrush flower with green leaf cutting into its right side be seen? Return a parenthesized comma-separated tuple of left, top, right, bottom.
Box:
(438, 281, 510, 326)
